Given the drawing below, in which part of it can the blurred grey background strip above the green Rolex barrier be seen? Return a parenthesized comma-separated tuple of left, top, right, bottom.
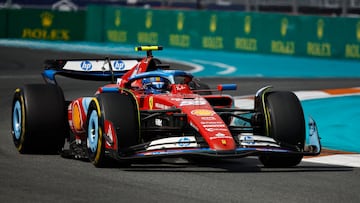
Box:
(0, 0, 360, 16)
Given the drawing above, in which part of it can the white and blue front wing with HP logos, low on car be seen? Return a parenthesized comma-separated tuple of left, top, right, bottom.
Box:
(116, 118, 321, 160)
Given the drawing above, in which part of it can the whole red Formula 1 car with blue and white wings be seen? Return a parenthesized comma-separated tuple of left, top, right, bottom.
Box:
(12, 46, 321, 167)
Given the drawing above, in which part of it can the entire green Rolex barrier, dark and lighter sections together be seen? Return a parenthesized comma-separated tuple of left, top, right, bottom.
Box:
(0, 5, 360, 60)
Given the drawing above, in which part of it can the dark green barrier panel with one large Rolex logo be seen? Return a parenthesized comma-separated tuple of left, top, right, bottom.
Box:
(7, 9, 85, 41)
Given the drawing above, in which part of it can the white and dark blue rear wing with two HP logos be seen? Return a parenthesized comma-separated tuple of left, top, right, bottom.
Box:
(42, 58, 141, 84)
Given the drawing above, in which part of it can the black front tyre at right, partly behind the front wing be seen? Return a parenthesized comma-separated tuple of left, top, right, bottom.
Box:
(259, 91, 305, 167)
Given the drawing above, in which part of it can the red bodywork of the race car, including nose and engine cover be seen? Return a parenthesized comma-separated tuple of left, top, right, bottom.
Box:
(68, 56, 236, 150)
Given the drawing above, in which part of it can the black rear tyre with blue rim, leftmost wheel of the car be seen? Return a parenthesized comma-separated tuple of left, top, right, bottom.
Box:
(11, 84, 69, 154)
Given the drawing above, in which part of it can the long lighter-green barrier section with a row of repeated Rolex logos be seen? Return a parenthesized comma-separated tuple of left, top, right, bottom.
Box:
(87, 6, 360, 59)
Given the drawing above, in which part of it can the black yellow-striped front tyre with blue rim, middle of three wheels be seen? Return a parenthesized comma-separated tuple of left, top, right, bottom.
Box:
(87, 92, 140, 167)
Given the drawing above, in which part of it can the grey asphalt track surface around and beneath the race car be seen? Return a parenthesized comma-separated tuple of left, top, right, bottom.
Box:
(0, 47, 360, 202)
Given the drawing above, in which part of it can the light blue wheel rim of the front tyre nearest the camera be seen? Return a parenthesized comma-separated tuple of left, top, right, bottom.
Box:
(87, 110, 99, 153)
